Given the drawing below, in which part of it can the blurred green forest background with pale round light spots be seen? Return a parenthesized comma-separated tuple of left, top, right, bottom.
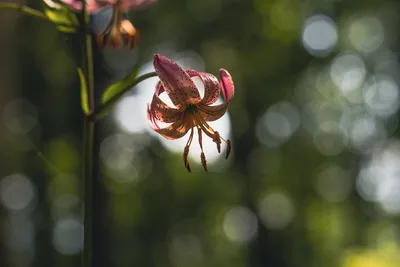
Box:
(0, 0, 400, 267)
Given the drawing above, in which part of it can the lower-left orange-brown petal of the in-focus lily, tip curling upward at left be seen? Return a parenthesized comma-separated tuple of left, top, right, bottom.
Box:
(147, 105, 191, 140)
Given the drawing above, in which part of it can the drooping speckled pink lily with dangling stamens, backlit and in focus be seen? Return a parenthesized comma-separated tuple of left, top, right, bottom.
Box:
(147, 54, 234, 172)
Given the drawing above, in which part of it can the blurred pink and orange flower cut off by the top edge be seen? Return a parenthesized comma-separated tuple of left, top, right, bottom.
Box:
(61, 0, 156, 49)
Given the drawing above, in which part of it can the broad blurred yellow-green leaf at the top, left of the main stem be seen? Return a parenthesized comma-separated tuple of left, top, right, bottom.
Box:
(43, 0, 79, 33)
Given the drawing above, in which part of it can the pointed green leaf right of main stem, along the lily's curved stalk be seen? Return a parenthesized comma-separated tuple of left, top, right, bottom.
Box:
(96, 64, 140, 118)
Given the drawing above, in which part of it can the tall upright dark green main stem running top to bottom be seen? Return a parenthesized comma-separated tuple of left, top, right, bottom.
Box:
(81, 0, 96, 267)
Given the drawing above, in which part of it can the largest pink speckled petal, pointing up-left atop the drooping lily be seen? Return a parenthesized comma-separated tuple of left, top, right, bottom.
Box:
(153, 54, 201, 111)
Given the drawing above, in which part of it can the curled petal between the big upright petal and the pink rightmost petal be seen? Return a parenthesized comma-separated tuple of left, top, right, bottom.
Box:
(186, 70, 220, 105)
